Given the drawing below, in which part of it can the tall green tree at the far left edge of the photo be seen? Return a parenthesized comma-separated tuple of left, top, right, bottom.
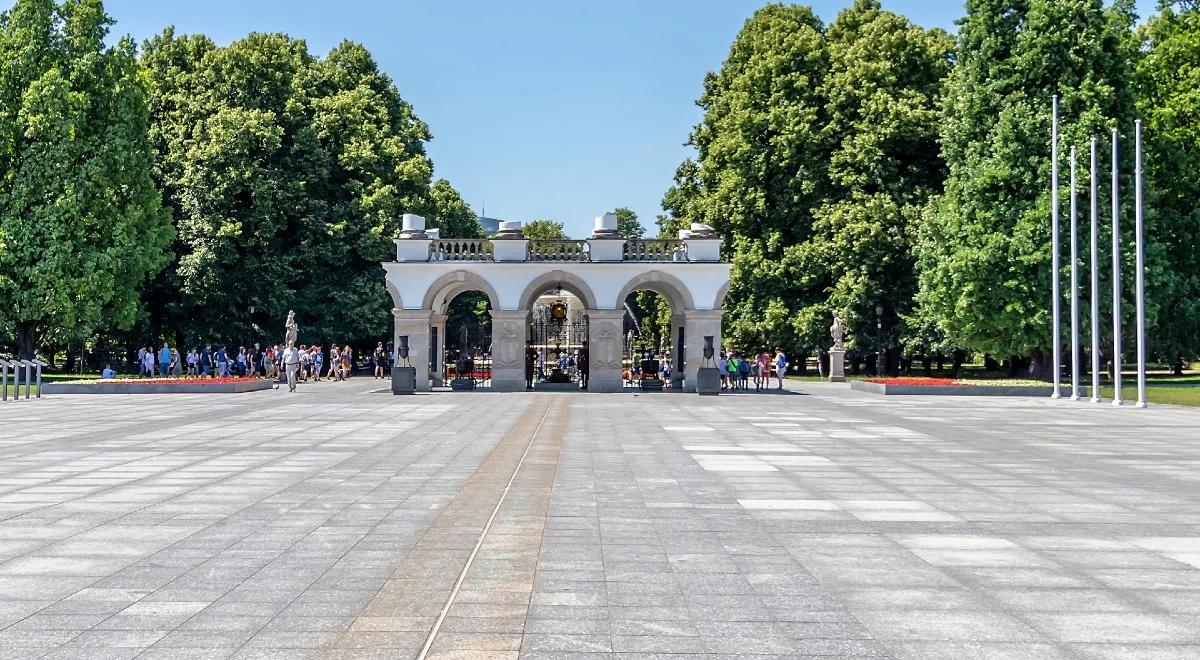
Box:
(0, 0, 172, 359)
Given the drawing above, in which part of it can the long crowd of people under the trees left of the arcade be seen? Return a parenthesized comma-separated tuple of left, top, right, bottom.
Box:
(120, 342, 392, 382)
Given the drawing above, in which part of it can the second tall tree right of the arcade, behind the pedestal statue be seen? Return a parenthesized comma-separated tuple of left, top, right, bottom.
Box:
(785, 0, 954, 362)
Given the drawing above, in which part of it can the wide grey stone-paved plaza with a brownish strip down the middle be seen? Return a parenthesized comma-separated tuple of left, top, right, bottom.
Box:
(0, 379, 1200, 660)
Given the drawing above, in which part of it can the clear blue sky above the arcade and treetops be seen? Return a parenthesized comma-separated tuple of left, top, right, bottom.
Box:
(0, 0, 1154, 236)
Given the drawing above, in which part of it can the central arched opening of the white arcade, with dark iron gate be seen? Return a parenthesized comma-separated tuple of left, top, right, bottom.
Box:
(526, 283, 590, 390)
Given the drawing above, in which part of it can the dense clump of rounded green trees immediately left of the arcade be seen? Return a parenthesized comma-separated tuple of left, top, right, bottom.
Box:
(143, 29, 482, 350)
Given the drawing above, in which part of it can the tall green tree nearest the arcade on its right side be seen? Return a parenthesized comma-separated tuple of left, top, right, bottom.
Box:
(676, 5, 830, 360)
